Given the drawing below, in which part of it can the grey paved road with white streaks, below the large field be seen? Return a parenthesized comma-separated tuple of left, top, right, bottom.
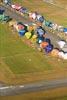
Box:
(0, 79, 67, 96)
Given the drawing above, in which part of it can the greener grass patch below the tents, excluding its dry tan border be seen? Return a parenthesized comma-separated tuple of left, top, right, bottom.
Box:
(0, 24, 52, 74)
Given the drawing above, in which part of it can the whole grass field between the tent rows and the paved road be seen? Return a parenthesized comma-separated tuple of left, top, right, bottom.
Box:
(0, 21, 67, 83)
